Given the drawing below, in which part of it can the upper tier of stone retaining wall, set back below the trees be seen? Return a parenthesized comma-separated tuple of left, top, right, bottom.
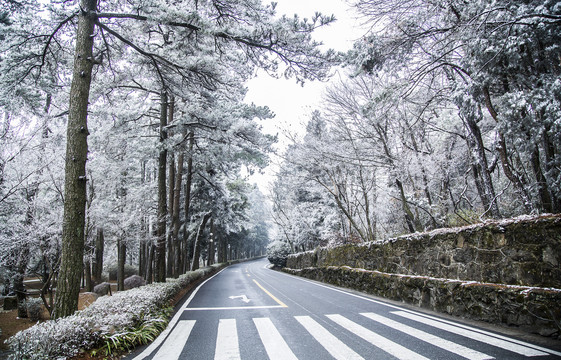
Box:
(287, 215, 561, 289)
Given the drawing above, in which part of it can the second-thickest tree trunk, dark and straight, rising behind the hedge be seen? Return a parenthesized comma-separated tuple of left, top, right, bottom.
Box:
(154, 91, 168, 282)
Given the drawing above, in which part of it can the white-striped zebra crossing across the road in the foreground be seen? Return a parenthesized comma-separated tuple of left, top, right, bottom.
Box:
(147, 311, 561, 360)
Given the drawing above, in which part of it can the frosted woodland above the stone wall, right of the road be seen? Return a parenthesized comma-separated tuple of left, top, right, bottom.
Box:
(272, 0, 561, 251)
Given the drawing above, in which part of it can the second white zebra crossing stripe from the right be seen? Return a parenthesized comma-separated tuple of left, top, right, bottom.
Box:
(361, 313, 494, 360)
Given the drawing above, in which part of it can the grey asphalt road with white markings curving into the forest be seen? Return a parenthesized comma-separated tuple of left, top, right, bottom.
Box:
(129, 259, 561, 360)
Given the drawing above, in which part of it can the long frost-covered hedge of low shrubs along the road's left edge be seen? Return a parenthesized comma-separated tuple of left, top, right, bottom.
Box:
(7, 264, 223, 360)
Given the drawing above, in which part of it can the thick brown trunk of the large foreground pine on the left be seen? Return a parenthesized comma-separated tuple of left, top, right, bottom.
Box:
(53, 0, 97, 318)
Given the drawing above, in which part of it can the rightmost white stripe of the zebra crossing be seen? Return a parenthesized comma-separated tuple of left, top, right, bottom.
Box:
(392, 311, 549, 356)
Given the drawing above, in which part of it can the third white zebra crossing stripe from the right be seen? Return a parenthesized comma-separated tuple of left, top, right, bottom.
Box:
(326, 314, 429, 360)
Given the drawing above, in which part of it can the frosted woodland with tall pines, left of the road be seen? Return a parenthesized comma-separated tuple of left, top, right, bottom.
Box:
(0, 0, 336, 318)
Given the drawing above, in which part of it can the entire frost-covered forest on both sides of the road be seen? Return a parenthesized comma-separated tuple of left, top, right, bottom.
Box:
(0, 0, 561, 326)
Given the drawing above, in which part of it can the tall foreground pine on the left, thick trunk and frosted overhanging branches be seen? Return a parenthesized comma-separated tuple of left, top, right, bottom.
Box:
(2, 0, 335, 317)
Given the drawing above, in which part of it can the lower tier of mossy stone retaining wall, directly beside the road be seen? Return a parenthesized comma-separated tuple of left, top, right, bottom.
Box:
(283, 266, 561, 337)
